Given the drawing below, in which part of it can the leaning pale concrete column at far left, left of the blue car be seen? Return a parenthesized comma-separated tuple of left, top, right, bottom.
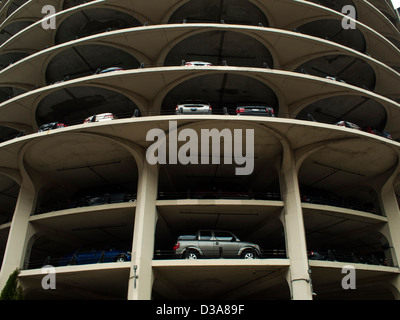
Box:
(0, 181, 37, 290)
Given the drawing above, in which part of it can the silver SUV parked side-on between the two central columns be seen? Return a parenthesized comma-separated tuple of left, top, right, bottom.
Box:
(174, 230, 261, 259)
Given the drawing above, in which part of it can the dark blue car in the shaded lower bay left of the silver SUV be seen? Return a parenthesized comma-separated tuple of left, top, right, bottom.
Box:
(58, 247, 131, 266)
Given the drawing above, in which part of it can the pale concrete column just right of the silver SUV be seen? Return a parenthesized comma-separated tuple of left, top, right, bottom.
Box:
(280, 147, 312, 300)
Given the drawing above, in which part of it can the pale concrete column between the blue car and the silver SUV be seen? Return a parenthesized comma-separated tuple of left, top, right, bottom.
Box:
(128, 160, 158, 300)
